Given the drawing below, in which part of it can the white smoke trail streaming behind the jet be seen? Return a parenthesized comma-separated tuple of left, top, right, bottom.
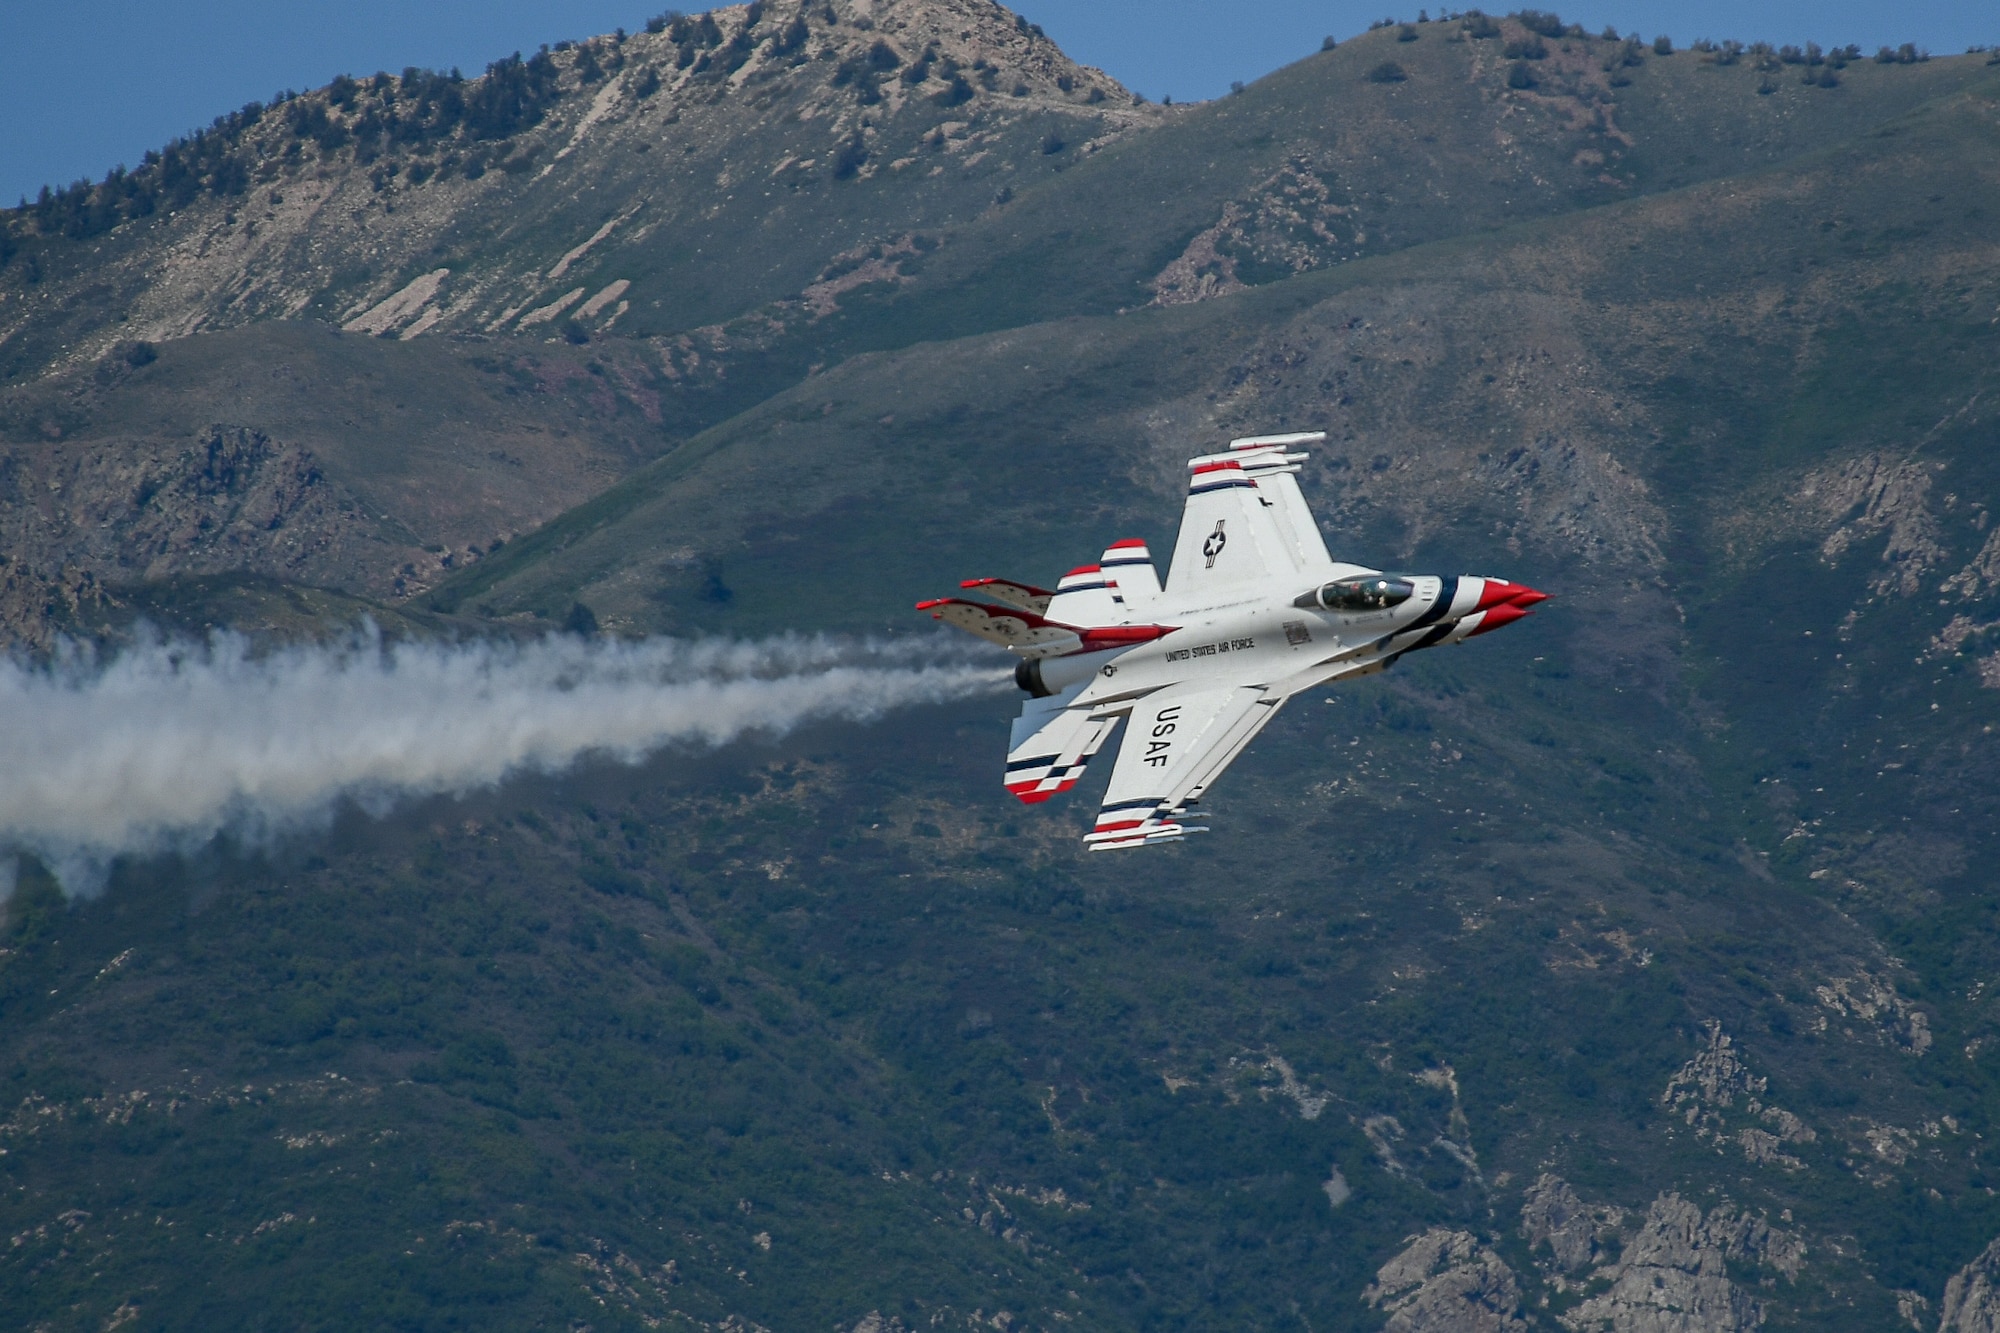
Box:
(0, 626, 1002, 899)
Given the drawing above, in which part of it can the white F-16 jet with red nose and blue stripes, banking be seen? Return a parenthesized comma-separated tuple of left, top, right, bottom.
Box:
(916, 432, 1548, 851)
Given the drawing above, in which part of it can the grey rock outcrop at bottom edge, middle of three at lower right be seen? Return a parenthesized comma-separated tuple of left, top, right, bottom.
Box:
(1562, 1193, 1806, 1333)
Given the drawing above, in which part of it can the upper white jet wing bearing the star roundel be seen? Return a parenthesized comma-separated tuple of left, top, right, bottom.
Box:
(1166, 436, 1326, 596)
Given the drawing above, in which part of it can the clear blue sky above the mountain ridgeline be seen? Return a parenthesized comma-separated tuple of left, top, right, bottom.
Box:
(0, 0, 2000, 202)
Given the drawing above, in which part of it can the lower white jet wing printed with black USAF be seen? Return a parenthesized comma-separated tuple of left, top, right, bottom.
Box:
(1084, 683, 1284, 851)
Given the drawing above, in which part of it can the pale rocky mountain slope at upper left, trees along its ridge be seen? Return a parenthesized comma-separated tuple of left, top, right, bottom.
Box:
(0, 0, 1162, 376)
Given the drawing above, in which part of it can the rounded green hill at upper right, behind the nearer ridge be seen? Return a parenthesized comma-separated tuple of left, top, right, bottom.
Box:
(800, 18, 1990, 344)
